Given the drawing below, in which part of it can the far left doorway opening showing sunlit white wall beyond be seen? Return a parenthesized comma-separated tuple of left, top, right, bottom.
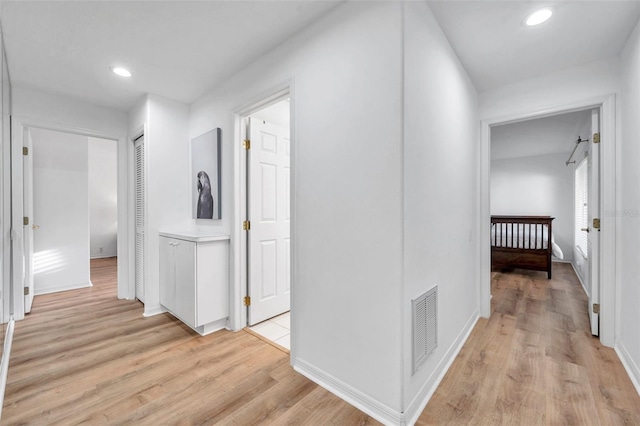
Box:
(23, 126, 118, 313)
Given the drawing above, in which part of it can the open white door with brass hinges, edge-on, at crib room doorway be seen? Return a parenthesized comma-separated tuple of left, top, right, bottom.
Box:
(587, 109, 600, 336)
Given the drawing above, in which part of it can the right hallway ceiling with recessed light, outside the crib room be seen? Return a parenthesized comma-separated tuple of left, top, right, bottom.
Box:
(429, 0, 640, 92)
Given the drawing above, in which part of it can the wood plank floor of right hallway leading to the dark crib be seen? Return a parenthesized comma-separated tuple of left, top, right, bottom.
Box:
(417, 263, 640, 425)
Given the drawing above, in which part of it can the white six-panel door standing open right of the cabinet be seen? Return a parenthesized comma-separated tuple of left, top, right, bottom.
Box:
(247, 118, 291, 325)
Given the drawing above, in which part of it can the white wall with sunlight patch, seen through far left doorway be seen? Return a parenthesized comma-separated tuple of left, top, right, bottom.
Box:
(30, 129, 91, 294)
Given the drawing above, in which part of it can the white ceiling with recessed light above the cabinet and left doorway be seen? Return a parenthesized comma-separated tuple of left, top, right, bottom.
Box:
(2, 0, 344, 111)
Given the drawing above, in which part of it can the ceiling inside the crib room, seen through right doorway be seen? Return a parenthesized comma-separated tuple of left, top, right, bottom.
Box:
(491, 110, 591, 160)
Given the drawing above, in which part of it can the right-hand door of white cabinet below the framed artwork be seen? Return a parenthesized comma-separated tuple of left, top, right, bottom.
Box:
(172, 239, 196, 326)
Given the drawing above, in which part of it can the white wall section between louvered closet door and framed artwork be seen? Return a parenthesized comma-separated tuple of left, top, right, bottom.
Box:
(128, 95, 191, 315)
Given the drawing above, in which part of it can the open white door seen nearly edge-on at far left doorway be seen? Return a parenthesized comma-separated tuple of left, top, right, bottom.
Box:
(22, 128, 38, 314)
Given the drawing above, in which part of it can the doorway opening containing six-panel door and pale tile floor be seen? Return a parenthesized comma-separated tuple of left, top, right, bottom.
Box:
(245, 95, 291, 350)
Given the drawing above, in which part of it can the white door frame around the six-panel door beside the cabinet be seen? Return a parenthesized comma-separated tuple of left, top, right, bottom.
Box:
(229, 79, 297, 332)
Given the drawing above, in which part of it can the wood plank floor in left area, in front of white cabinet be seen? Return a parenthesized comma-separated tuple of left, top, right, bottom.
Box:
(2, 258, 379, 425)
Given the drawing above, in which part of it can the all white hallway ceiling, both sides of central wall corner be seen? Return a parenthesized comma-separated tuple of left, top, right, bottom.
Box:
(1, 0, 640, 111)
